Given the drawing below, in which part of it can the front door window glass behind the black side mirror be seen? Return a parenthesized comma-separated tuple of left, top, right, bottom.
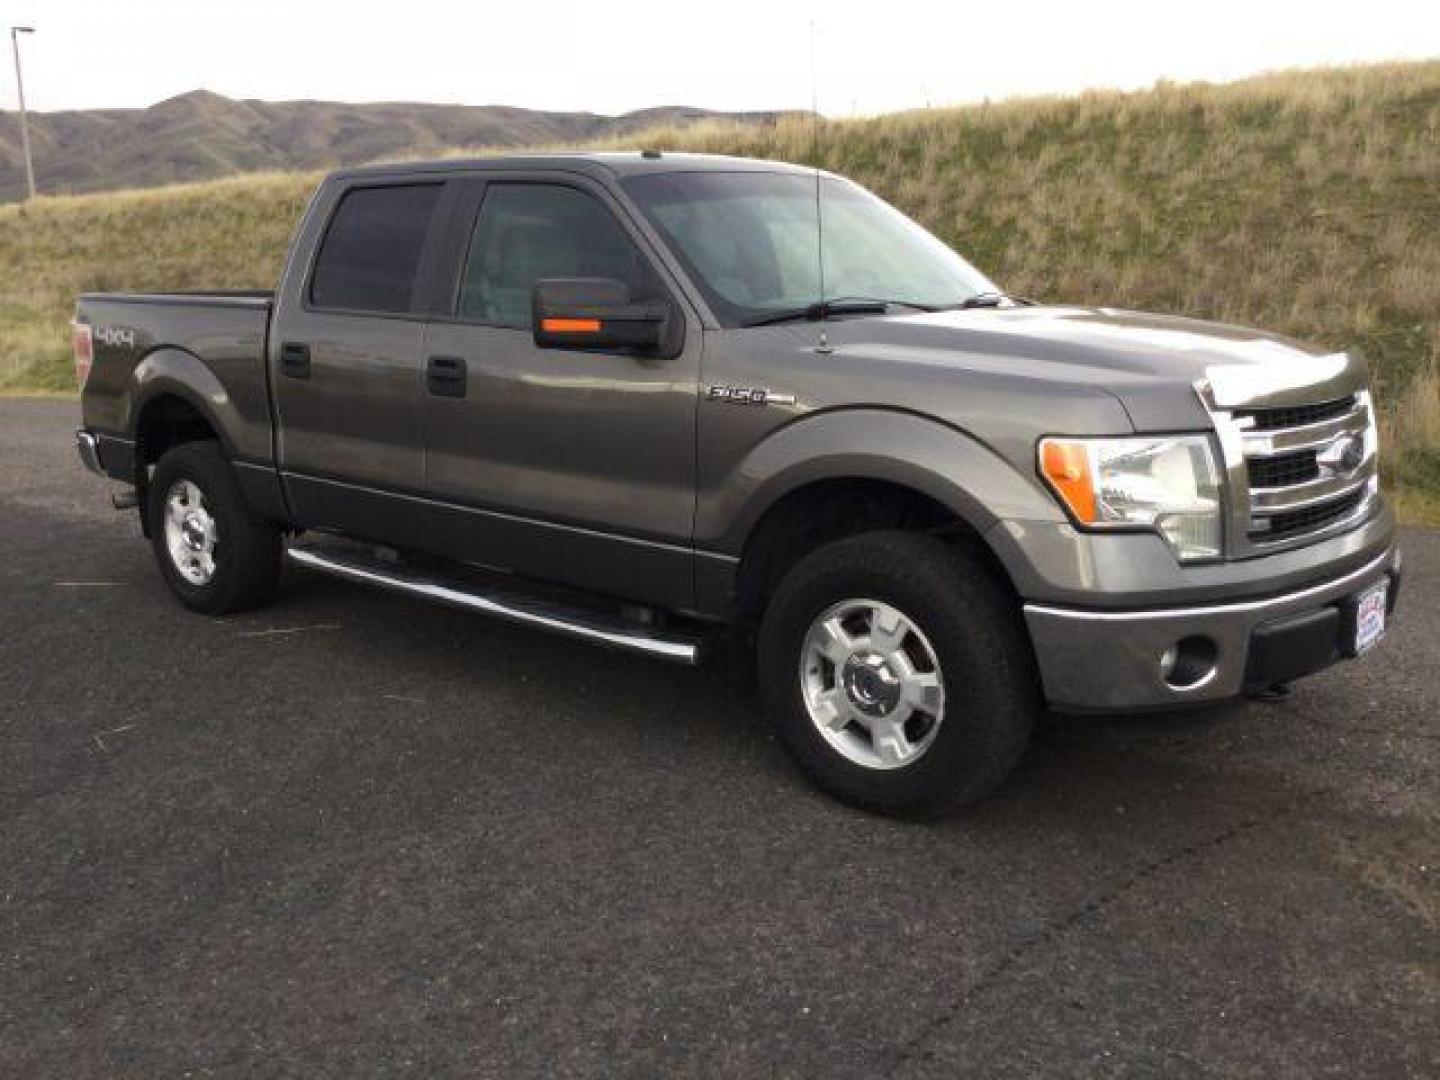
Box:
(459, 184, 661, 330)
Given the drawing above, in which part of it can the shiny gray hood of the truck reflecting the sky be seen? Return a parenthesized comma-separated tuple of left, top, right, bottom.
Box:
(829, 307, 1365, 432)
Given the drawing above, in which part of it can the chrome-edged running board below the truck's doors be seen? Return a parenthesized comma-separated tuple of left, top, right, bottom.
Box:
(285, 546, 700, 665)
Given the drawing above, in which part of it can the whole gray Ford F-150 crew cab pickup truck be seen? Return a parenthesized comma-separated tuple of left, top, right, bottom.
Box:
(75, 151, 1400, 812)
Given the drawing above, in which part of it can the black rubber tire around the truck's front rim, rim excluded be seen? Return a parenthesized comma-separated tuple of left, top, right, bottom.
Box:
(759, 531, 1043, 816)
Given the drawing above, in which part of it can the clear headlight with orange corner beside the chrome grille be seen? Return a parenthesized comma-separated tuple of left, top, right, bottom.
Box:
(1040, 435, 1221, 563)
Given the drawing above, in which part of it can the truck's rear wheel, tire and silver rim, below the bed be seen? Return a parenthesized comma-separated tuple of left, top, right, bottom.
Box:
(145, 442, 281, 615)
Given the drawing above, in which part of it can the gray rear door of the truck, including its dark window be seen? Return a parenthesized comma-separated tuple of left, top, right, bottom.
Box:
(271, 179, 446, 543)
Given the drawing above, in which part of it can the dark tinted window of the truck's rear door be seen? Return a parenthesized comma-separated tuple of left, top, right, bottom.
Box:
(310, 184, 441, 312)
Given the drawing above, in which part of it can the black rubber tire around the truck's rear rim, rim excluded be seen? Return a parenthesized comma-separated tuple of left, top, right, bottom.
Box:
(145, 442, 281, 615)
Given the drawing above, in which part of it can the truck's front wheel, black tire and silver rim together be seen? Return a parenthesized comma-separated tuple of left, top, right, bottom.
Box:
(759, 531, 1041, 816)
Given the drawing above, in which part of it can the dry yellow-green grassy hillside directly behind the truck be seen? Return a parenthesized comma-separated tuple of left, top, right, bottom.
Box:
(0, 62, 1440, 520)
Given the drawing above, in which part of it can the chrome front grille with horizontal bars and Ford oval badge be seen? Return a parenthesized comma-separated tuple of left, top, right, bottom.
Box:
(1201, 377, 1378, 557)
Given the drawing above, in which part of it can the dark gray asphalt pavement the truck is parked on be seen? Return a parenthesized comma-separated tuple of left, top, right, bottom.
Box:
(0, 400, 1440, 1079)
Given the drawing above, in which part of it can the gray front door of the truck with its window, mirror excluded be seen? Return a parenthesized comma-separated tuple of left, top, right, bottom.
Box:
(420, 177, 701, 608)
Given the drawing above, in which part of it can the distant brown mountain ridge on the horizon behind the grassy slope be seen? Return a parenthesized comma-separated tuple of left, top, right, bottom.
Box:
(0, 89, 800, 202)
